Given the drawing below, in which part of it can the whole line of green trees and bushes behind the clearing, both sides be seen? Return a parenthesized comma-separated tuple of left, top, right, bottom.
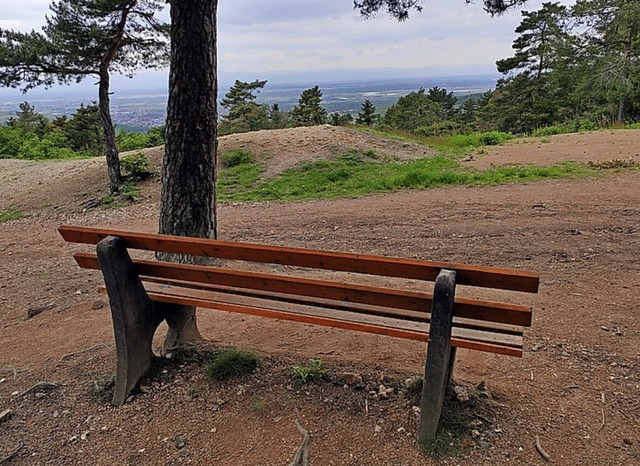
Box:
(0, 0, 640, 159)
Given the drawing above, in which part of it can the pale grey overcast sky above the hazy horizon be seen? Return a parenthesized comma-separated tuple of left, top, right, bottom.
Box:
(0, 0, 575, 93)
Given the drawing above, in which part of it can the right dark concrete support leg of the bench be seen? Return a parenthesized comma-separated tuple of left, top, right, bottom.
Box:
(418, 269, 456, 444)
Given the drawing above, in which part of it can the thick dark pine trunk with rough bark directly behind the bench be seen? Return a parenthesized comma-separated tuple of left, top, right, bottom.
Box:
(159, 0, 218, 345)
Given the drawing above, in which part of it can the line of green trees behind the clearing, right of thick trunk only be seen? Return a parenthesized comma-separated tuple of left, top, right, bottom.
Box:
(220, 0, 640, 136)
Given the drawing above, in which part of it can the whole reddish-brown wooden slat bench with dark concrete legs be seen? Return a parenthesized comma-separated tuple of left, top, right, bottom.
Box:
(59, 226, 539, 440)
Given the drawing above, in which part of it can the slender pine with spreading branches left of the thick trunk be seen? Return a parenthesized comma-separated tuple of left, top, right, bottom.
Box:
(0, 0, 168, 192)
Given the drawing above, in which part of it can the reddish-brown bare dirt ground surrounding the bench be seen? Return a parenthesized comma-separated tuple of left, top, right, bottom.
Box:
(0, 129, 640, 466)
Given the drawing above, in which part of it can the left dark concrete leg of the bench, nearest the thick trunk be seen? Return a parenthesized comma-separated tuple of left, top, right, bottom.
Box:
(96, 236, 163, 406)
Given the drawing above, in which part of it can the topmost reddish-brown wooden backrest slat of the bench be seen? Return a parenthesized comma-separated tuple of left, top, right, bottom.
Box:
(58, 226, 540, 293)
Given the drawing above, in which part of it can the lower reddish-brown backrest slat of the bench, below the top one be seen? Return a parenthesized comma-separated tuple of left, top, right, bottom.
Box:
(74, 253, 531, 327)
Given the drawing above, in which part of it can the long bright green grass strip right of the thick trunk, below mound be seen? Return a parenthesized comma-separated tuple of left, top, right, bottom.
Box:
(218, 152, 596, 202)
